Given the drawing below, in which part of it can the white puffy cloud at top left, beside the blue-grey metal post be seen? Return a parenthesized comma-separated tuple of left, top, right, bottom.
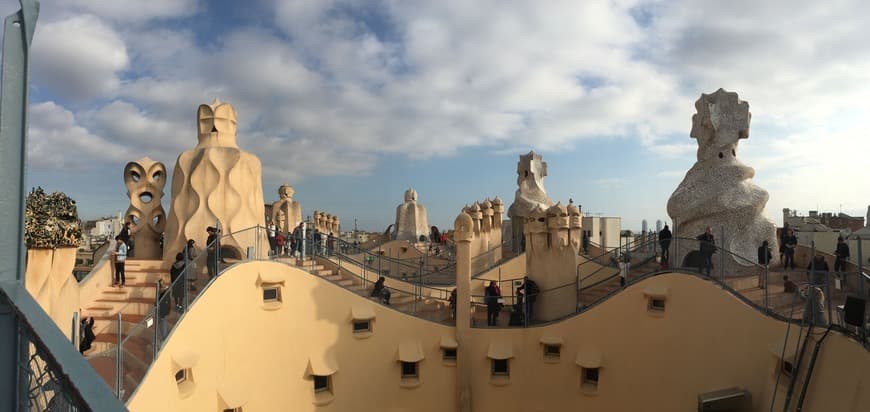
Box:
(31, 15, 129, 101)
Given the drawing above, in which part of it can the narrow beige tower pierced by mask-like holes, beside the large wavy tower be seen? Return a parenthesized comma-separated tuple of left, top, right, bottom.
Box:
(124, 157, 166, 259)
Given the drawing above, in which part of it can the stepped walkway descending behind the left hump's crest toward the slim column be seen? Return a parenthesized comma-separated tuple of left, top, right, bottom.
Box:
(276, 257, 453, 323)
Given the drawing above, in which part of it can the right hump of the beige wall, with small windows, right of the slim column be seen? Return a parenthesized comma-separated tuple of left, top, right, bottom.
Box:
(460, 274, 870, 411)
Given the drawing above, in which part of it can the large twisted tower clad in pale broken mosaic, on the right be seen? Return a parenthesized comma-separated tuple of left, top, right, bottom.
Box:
(668, 89, 787, 272)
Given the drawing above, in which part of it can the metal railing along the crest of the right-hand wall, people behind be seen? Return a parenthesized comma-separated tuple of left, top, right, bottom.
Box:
(470, 232, 870, 344)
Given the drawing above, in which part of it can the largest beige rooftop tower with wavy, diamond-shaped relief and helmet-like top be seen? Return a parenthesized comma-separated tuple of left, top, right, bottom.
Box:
(163, 100, 268, 260)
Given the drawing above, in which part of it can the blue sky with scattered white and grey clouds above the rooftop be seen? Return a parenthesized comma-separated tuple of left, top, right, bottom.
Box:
(0, 0, 870, 231)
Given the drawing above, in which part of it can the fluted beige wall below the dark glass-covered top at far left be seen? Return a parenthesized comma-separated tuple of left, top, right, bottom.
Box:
(24, 247, 79, 338)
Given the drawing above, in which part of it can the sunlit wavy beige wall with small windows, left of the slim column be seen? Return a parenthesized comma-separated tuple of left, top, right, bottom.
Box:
(128, 262, 455, 412)
